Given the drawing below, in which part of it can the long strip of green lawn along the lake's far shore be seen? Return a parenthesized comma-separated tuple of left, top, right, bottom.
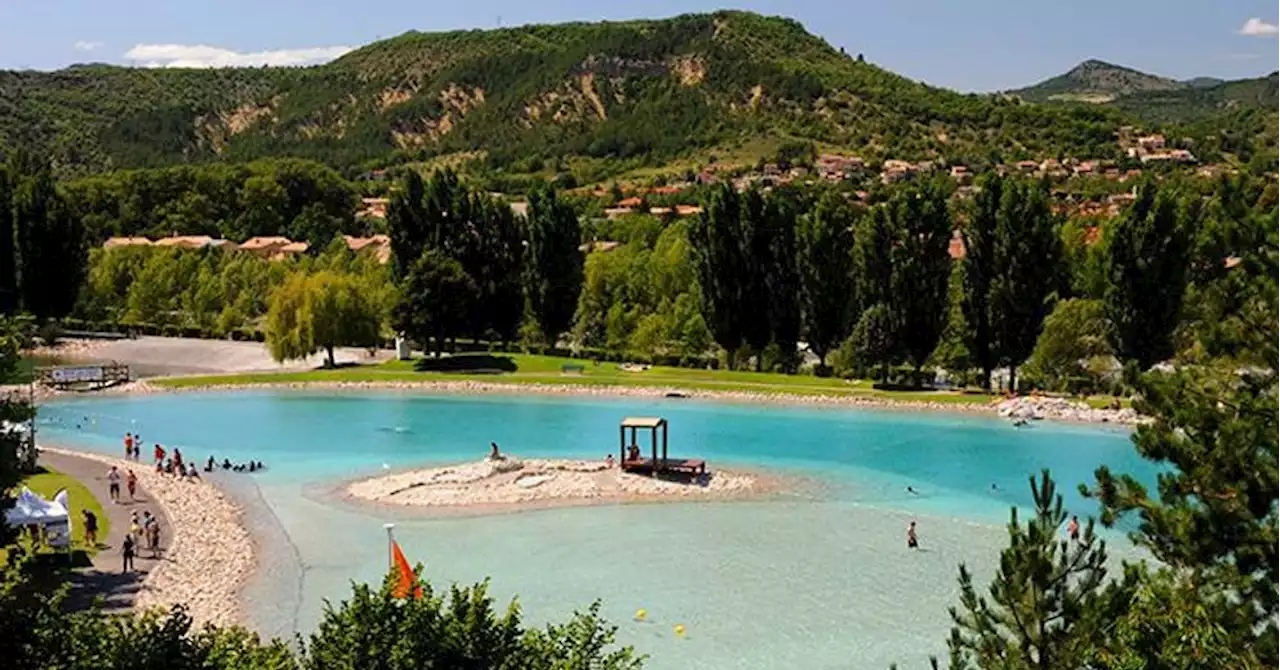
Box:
(152, 354, 992, 404)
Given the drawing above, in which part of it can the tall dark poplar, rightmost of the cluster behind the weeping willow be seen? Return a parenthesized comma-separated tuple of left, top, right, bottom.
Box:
(525, 187, 582, 347)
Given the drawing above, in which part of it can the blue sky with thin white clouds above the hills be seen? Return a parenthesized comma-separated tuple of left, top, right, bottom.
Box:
(0, 0, 1280, 91)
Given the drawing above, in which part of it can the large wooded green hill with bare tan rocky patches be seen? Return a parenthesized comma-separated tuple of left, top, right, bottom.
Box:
(0, 12, 1123, 174)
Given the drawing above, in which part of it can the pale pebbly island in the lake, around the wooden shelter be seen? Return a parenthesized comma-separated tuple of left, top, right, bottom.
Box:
(342, 456, 786, 510)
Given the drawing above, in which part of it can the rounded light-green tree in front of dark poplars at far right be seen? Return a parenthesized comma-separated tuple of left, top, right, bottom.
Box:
(1027, 298, 1114, 391)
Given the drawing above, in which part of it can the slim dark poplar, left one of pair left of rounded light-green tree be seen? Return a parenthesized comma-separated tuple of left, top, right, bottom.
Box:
(961, 176, 1007, 391)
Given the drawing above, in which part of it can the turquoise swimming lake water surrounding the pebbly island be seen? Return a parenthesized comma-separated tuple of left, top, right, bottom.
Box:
(40, 392, 1153, 669)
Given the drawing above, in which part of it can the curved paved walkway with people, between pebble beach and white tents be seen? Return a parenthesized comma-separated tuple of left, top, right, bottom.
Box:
(40, 451, 173, 612)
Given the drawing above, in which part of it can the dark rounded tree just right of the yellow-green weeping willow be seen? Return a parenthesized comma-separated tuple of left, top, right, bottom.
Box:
(394, 249, 476, 357)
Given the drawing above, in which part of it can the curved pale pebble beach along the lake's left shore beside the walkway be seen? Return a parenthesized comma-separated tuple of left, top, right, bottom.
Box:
(41, 447, 255, 626)
